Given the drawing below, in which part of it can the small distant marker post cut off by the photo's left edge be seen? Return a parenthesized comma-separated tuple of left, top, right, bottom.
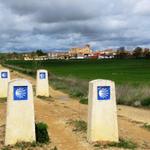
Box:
(0, 69, 10, 98)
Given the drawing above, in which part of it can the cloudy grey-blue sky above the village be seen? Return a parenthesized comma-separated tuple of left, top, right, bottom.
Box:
(0, 0, 150, 52)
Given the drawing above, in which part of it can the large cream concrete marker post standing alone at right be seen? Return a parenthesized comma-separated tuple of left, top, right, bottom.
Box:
(87, 80, 119, 142)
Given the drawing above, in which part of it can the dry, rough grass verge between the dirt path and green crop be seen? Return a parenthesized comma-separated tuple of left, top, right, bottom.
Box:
(3, 64, 150, 107)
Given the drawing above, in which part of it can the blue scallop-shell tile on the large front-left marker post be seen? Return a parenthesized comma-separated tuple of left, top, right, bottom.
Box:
(13, 86, 28, 101)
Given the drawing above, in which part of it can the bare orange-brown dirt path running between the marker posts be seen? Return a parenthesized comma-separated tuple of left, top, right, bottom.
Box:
(0, 67, 150, 150)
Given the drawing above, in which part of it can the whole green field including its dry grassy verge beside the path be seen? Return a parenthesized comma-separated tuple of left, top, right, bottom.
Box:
(5, 59, 150, 107)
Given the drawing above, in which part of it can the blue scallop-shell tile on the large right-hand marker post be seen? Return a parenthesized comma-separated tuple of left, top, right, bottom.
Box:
(97, 86, 110, 100)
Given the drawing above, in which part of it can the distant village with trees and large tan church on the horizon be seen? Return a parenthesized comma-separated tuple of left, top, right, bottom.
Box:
(0, 44, 150, 61)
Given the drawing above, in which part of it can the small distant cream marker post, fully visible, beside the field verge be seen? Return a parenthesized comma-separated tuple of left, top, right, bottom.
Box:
(36, 70, 49, 97)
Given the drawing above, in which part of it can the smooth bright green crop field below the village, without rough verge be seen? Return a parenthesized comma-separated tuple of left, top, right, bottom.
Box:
(4, 59, 150, 84)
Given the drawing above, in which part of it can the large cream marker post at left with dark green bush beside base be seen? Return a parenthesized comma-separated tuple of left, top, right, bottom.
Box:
(5, 79, 36, 145)
